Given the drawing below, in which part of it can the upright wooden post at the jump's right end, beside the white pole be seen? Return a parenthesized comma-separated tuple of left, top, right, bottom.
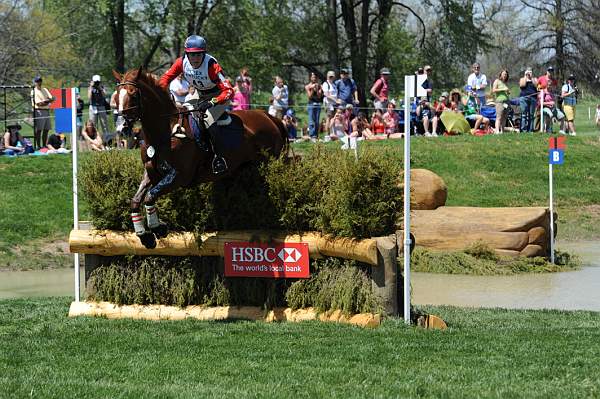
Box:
(371, 234, 399, 316)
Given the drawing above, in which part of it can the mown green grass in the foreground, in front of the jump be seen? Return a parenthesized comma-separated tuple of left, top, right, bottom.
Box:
(0, 298, 600, 399)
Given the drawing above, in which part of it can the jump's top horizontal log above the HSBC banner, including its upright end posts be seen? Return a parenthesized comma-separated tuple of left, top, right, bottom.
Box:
(69, 230, 402, 315)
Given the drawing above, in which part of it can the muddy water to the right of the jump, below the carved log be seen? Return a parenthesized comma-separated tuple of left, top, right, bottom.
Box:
(411, 242, 600, 311)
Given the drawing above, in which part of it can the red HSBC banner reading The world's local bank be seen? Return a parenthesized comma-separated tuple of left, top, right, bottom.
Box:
(225, 242, 310, 278)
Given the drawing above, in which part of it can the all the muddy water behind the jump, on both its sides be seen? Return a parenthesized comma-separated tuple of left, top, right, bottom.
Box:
(0, 242, 600, 311)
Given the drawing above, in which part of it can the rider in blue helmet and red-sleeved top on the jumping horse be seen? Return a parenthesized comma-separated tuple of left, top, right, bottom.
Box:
(159, 35, 233, 174)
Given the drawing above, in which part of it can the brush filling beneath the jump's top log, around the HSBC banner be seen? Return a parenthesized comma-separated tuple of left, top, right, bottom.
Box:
(86, 256, 381, 314)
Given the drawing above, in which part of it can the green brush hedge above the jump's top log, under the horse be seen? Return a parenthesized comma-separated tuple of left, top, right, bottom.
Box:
(80, 146, 402, 238)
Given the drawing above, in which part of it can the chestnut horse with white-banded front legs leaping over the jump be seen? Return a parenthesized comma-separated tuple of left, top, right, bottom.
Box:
(113, 67, 289, 248)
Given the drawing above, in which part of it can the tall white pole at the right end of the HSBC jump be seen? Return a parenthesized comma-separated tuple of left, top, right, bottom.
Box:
(404, 76, 417, 324)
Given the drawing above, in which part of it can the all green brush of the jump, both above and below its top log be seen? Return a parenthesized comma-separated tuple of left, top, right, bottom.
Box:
(80, 146, 402, 314)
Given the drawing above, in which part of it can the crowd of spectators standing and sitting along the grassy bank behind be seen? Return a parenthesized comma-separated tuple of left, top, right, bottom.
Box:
(0, 63, 580, 154)
